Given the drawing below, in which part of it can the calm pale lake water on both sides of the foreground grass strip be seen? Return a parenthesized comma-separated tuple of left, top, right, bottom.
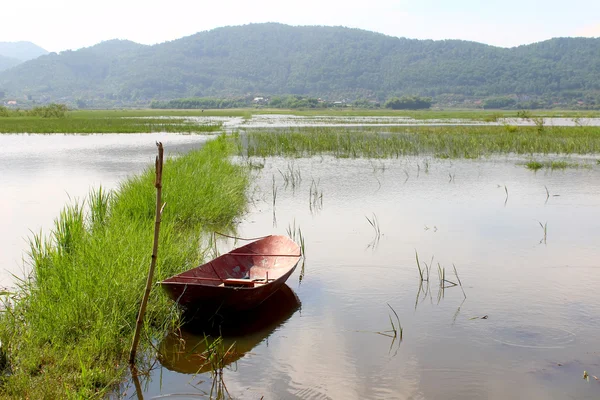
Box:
(0, 135, 600, 399)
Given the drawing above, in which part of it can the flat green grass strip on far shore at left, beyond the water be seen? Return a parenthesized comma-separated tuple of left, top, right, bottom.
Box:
(0, 112, 221, 133)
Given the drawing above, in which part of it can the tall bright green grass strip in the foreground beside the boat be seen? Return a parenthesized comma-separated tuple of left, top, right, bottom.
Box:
(0, 137, 249, 399)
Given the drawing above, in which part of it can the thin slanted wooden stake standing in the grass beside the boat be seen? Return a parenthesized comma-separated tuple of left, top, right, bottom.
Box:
(129, 142, 166, 365)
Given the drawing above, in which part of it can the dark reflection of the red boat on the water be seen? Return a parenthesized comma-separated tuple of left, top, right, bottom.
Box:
(159, 284, 300, 374)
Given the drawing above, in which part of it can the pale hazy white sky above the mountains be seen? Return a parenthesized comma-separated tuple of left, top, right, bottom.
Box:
(0, 0, 600, 52)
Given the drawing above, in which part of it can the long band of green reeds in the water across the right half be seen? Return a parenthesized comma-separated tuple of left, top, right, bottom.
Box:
(244, 126, 600, 158)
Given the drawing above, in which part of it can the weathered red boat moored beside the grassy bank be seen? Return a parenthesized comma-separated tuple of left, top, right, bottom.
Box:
(160, 235, 301, 313)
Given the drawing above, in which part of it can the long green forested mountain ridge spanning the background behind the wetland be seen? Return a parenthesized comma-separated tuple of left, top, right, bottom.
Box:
(0, 23, 600, 105)
